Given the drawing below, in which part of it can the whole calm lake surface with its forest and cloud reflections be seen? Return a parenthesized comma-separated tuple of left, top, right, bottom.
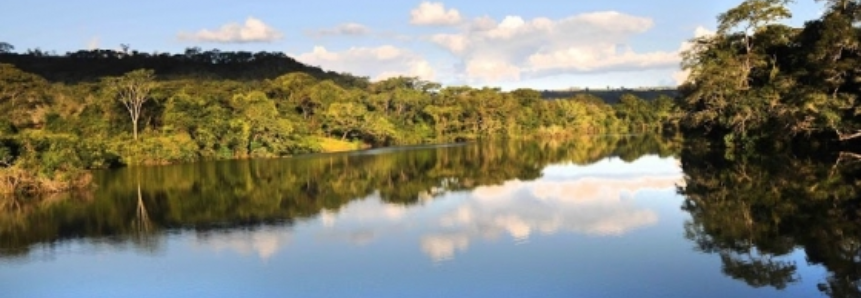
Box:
(0, 137, 848, 298)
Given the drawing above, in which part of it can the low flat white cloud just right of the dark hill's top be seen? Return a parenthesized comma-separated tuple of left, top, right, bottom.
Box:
(296, 45, 435, 80)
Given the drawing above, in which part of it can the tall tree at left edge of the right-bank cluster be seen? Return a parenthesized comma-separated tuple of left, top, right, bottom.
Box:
(679, 0, 805, 146)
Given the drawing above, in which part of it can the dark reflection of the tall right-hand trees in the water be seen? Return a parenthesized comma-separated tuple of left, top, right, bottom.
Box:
(681, 150, 861, 297)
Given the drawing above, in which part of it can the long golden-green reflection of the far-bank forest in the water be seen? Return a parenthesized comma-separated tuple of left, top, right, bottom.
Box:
(0, 136, 679, 256)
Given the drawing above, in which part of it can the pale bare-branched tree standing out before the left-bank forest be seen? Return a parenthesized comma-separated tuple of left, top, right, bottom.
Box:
(107, 69, 156, 140)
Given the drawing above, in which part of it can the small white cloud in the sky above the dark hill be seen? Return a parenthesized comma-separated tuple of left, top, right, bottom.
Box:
(179, 17, 284, 43)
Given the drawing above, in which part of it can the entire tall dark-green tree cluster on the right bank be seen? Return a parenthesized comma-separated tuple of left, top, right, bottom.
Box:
(680, 0, 861, 146)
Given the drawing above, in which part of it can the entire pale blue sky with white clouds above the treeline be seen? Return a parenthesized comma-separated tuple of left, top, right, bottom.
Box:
(0, 0, 821, 89)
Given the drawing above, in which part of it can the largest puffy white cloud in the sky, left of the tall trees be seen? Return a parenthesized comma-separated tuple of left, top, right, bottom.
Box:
(429, 11, 700, 83)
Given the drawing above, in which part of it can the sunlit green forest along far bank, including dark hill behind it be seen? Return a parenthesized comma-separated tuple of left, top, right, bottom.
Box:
(0, 49, 677, 192)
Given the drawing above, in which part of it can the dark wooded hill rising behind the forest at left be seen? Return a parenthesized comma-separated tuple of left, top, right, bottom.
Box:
(0, 48, 369, 87)
